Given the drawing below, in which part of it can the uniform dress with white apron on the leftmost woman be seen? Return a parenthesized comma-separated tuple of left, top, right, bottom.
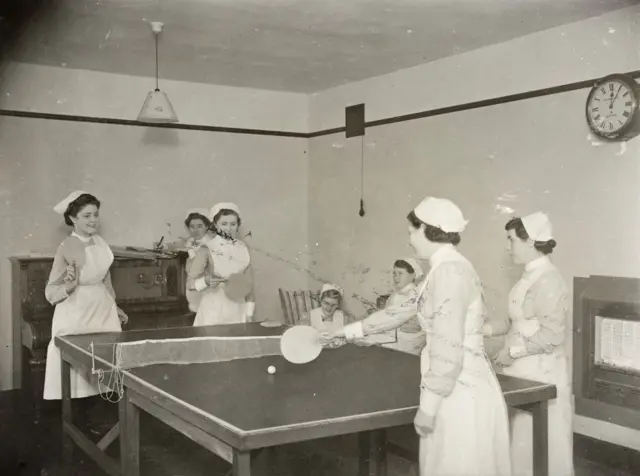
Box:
(43, 233, 122, 400)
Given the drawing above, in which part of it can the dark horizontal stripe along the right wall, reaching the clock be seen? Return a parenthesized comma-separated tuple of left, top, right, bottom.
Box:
(309, 70, 640, 137)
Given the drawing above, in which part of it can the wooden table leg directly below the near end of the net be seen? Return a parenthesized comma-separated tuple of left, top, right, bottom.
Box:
(118, 388, 140, 476)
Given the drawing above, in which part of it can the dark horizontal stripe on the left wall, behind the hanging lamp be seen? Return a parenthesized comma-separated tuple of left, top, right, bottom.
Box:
(0, 109, 309, 139)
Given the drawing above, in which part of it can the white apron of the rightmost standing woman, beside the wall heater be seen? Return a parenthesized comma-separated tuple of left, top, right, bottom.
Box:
(502, 262, 574, 476)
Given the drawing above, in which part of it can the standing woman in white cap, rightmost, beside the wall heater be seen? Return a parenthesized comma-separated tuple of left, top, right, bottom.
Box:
(485, 212, 574, 476)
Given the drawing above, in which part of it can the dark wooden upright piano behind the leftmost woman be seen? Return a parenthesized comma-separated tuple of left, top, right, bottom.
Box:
(11, 247, 194, 410)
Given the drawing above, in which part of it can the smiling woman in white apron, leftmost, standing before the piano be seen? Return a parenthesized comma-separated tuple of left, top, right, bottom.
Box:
(44, 191, 127, 400)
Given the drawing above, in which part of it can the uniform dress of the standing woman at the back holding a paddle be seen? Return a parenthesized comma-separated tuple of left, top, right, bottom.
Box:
(190, 235, 251, 326)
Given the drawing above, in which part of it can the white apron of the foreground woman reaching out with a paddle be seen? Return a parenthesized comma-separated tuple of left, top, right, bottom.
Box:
(418, 252, 511, 476)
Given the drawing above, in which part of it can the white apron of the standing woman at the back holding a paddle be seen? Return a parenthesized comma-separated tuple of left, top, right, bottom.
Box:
(193, 236, 251, 326)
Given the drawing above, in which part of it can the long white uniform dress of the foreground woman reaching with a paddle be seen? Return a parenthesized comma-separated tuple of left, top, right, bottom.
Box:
(418, 245, 511, 476)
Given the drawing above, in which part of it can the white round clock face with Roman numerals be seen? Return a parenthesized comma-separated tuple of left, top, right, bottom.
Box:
(587, 79, 638, 136)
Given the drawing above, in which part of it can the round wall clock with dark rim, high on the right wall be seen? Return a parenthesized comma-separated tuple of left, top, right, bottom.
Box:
(586, 74, 640, 141)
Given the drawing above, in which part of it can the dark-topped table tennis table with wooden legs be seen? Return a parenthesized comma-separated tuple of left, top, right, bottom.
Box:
(55, 323, 556, 476)
